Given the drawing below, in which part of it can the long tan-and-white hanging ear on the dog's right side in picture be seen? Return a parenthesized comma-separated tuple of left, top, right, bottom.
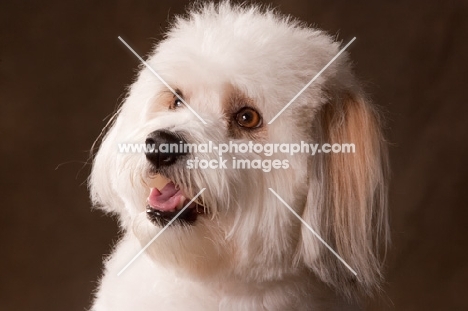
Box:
(297, 91, 389, 296)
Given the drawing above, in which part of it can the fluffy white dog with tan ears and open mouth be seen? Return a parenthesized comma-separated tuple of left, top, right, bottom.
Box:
(90, 2, 388, 311)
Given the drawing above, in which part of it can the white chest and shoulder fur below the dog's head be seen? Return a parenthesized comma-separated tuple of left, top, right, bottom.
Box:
(92, 234, 357, 311)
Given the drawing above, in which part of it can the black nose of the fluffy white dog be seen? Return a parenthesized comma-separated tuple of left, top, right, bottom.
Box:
(145, 130, 187, 168)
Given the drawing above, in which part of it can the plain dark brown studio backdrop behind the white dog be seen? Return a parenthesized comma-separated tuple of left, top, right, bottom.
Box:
(0, 1, 468, 310)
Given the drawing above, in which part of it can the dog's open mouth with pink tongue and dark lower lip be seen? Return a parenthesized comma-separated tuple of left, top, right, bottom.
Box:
(146, 176, 204, 226)
